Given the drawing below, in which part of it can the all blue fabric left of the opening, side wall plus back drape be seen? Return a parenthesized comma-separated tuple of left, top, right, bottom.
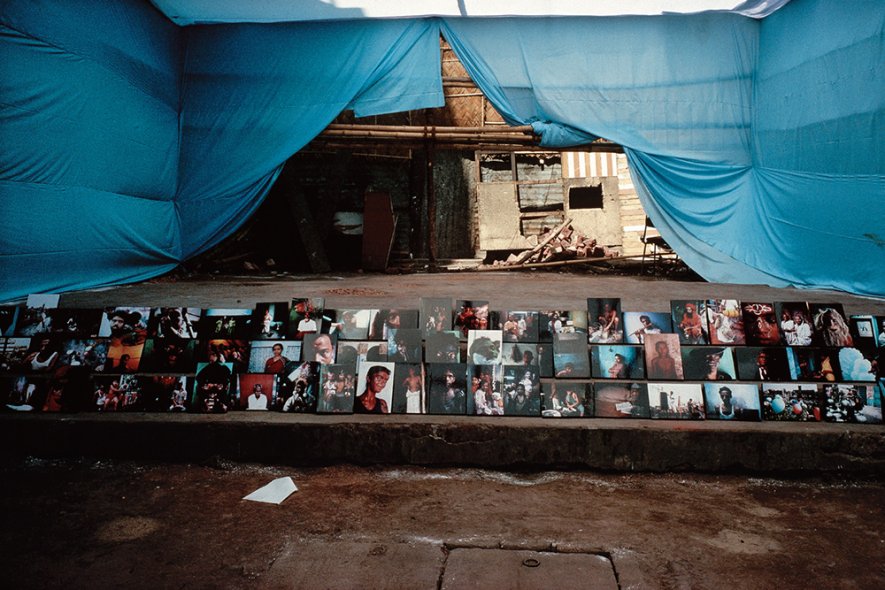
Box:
(0, 0, 443, 301)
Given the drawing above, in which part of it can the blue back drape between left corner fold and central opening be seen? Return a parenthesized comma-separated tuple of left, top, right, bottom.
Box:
(177, 20, 444, 258)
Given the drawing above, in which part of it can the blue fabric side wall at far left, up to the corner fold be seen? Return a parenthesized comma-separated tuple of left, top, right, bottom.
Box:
(0, 0, 181, 300)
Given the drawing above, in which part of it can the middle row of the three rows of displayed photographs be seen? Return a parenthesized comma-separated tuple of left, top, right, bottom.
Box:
(0, 328, 885, 381)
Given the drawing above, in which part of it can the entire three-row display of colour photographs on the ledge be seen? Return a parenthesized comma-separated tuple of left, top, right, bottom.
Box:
(0, 295, 885, 422)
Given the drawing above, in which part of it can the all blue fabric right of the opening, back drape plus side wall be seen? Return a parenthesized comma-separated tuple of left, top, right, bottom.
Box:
(443, 0, 885, 296)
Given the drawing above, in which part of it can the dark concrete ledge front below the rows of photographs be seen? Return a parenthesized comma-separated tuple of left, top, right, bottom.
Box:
(0, 412, 885, 478)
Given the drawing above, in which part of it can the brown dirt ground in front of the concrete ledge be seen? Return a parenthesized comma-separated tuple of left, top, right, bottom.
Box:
(0, 462, 885, 589)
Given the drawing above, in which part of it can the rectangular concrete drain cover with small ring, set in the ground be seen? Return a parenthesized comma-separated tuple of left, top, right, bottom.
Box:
(442, 549, 618, 590)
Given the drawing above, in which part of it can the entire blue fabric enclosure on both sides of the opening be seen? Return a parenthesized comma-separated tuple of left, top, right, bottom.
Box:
(0, 0, 885, 300)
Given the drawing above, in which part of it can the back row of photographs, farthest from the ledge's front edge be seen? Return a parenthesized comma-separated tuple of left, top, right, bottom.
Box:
(0, 295, 885, 348)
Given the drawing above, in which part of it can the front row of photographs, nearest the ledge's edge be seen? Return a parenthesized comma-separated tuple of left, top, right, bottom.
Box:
(0, 362, 885, 424)
